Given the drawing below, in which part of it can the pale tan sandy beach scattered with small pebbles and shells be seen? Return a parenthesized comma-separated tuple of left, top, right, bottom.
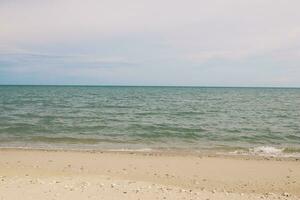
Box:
(0, 149, 300, 200)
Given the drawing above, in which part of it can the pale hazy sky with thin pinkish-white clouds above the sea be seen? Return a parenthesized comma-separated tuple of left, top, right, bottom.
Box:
(0, 0, 300, 87)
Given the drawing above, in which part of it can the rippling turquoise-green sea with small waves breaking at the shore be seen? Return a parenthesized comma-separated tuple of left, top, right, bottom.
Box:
(0, 86, 300, 154)
